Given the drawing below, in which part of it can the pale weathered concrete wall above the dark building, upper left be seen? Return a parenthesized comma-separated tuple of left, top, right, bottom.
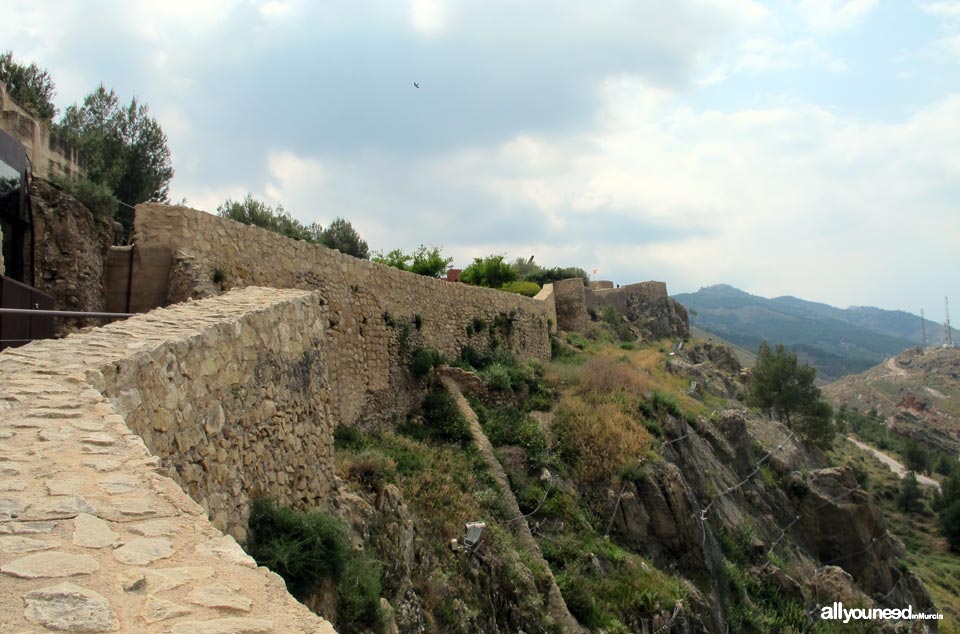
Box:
(0, 83, 84, 178)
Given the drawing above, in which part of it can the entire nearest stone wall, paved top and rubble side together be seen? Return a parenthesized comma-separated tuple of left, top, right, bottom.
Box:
(0, 288, 333, 634)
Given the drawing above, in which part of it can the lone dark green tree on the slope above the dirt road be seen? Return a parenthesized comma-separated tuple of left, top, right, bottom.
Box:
(747, 341, 835, 448)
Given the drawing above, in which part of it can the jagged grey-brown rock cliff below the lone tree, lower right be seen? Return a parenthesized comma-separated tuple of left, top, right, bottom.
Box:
(608, 402, 934, 632)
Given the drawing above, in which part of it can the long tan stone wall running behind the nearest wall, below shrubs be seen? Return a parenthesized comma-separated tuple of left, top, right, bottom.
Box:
(132, 204, 555, 425)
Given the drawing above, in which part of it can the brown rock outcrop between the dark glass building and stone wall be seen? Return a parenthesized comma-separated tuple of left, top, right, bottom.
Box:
(25, 178, 115, 336)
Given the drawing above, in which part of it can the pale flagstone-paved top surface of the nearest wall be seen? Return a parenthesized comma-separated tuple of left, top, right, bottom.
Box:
(0, 289, 334, 634)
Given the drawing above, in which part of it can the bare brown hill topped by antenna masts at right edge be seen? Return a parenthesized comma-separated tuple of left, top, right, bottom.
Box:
(824, 348, 960, 455)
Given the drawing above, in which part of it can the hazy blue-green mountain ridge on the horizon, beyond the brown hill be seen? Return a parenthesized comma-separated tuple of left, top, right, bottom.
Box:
(673, 284, 960, 381)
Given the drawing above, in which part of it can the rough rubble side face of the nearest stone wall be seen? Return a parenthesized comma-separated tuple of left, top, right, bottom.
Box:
(88, 287, 333, 542)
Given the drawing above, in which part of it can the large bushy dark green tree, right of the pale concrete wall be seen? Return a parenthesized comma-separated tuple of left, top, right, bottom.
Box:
(56, 84, 173, 205)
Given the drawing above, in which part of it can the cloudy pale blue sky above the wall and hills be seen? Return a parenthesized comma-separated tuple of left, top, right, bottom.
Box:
(0, 0, 960, 319)
